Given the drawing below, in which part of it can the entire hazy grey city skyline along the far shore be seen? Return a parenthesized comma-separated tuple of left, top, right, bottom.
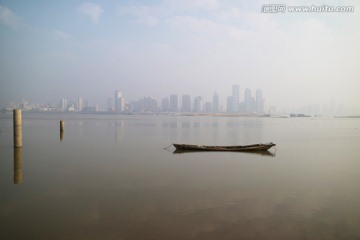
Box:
(2, 84, 360, 116)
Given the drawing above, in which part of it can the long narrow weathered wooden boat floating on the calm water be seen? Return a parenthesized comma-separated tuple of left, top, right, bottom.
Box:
(173, 143, 276, 152)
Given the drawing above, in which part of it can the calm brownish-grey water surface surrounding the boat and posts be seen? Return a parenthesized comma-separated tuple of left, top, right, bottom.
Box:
(0, 113, 360, 240)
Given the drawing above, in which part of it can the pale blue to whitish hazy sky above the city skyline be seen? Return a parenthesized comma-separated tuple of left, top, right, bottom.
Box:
(0, 0, 360, 107)
